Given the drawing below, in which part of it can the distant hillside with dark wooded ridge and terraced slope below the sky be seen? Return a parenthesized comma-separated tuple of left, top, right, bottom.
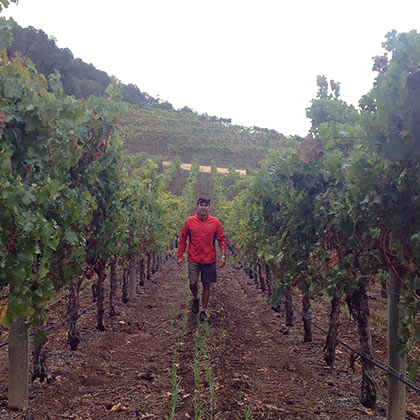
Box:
(8, 17, 295, 169)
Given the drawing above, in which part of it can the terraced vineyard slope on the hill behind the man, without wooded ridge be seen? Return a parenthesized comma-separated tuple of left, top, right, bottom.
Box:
(121, 106, 296, 168)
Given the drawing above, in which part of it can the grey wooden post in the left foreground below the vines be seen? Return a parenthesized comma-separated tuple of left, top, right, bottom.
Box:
(8, 317, 29, 410)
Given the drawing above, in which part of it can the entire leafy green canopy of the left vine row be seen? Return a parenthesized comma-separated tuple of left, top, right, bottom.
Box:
(0, 19, 181, 332)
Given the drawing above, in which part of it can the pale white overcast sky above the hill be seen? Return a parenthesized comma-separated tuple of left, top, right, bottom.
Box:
(2, 0, 420, 136)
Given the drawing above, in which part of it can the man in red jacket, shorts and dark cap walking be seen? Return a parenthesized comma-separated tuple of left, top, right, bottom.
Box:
(177, 197, 226, 321)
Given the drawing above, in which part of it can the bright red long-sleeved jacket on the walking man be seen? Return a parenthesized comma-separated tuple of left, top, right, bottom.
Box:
(177, 214, 226, 264)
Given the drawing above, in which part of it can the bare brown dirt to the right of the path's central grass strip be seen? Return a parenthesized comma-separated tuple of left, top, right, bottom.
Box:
(208, 270, 378, 420)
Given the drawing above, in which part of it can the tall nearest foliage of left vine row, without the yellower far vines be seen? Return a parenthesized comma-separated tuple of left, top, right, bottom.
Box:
(0, 27, 128, 325)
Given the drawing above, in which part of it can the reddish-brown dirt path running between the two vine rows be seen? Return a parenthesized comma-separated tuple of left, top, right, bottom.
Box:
(0, 260, 420, 420)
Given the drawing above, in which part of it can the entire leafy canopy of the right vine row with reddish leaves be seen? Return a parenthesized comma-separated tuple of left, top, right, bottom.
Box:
(221, 31, 420, 358)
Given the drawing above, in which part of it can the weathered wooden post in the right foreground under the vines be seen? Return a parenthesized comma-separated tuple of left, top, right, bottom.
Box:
(387, 268, 406, 420)
